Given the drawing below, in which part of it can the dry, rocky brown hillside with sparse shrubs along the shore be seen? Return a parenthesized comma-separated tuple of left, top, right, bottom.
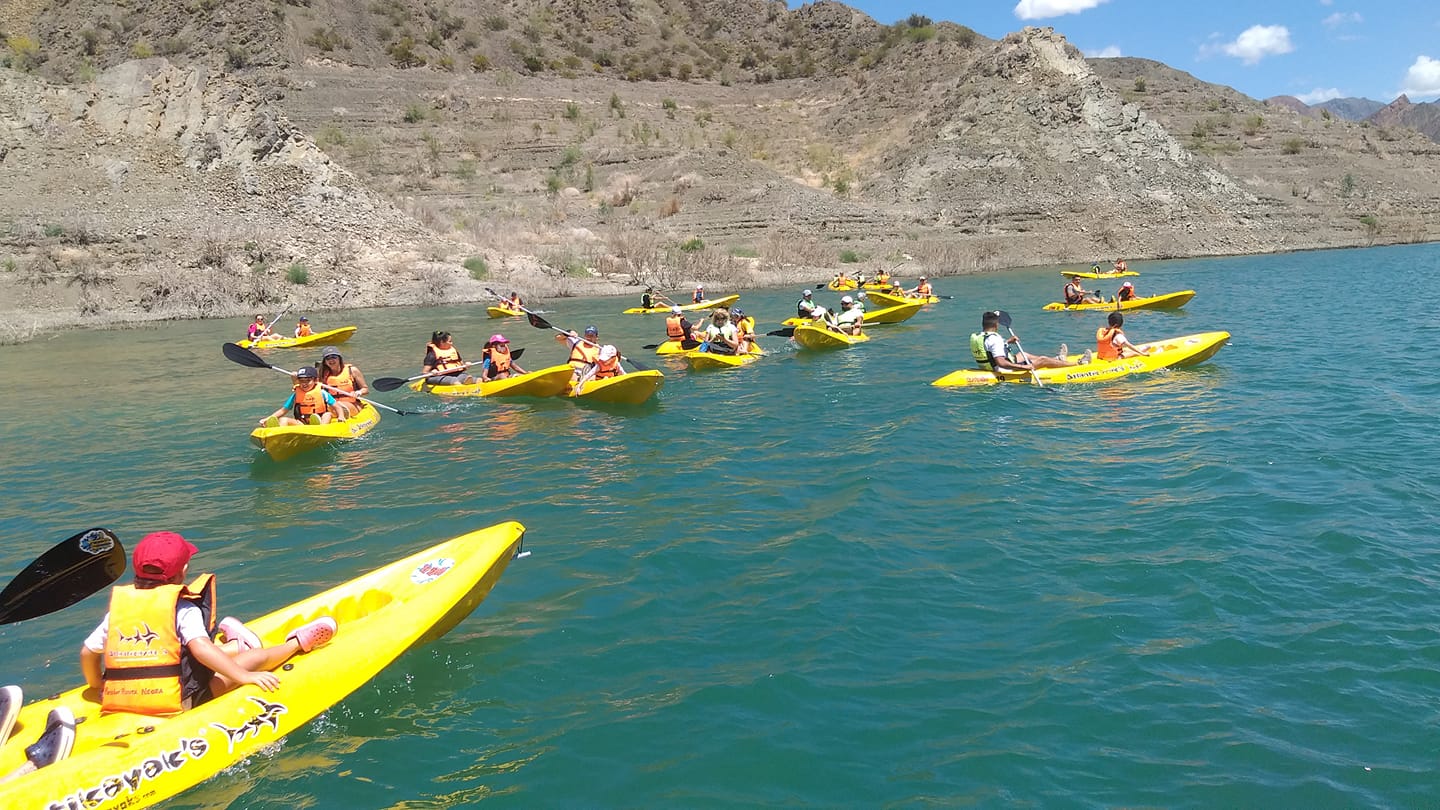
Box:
(0, 0, 1440, 337)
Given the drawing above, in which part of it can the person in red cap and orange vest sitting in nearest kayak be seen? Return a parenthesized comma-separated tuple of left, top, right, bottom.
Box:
(81, 532, 337, 716)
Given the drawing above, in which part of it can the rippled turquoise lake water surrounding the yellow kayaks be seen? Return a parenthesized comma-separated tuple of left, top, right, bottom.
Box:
(0, 245, 1440, 807)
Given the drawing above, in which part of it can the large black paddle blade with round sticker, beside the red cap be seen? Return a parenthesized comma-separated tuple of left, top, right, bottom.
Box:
(0, 529, 125, 624)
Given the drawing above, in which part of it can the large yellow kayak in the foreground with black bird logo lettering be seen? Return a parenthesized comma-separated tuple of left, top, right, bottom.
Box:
(0, 522, 526, 810)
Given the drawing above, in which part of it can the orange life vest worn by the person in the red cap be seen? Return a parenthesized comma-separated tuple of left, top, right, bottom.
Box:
(101, 574, 216, 715)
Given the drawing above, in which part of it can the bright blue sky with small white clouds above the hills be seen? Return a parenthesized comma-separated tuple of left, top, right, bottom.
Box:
(812, 0, 1440, 104)
